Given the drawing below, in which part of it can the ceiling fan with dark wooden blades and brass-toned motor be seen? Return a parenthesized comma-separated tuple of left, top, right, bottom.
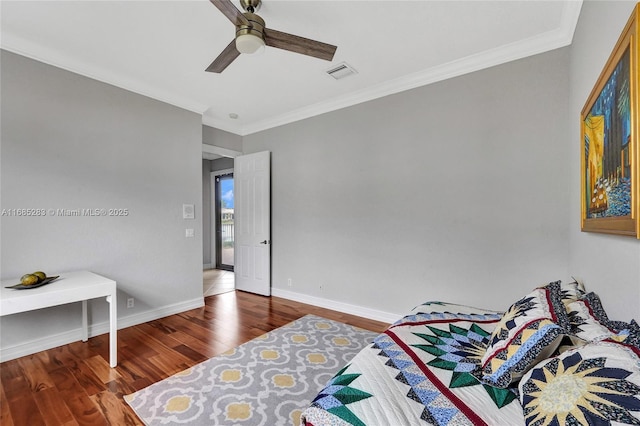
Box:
(206, 0, 337, 73)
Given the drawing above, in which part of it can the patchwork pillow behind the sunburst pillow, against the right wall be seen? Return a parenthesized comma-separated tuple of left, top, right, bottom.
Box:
(567, 293, 630, 342)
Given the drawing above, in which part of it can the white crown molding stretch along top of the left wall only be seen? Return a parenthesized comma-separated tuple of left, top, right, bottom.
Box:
(0, 30, 209, 114)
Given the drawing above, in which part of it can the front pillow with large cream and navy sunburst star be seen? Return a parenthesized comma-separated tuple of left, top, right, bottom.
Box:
(518, 342, 640, 425)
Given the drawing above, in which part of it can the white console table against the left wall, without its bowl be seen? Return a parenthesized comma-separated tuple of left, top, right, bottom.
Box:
(0, 271, 118, 367)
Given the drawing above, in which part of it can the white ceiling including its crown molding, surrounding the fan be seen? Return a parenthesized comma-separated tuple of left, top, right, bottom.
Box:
(0, 0, 582, 135)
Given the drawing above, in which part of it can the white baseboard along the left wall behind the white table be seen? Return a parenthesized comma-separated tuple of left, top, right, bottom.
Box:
(0, 297, 204, 362)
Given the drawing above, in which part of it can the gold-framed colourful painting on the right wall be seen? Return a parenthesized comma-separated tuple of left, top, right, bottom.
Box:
(580, 5, 640, 238)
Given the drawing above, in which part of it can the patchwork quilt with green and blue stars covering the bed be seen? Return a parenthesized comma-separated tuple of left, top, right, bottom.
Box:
(303, 302, 524, 426)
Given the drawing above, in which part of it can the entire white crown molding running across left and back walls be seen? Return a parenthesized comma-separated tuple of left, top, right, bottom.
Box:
(0, 0, 582, 136)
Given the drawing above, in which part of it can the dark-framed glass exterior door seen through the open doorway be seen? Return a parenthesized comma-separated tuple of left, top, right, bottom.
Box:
(214, 173, 235, 271)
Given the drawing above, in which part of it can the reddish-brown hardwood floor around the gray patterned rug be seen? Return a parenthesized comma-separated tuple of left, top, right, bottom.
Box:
(0, 291, 388, 426)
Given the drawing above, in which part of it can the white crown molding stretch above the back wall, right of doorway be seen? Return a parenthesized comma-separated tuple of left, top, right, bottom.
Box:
(238, 0, 582, 136)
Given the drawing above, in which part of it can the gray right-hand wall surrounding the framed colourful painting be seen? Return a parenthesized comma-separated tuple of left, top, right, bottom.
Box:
(567, 1, 640, 320)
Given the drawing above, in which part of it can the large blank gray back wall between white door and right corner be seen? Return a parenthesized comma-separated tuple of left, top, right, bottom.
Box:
(243, 49, 575, 313)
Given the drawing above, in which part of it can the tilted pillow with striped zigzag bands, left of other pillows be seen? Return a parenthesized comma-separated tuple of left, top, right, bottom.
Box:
(481, 281, 569, 388)
